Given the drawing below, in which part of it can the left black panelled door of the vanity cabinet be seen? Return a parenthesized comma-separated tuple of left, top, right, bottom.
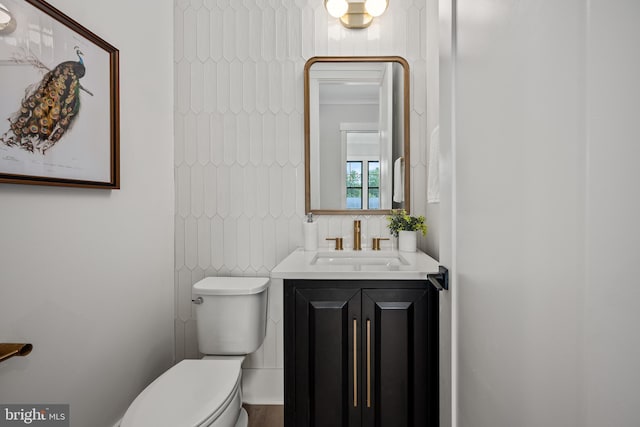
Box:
(289, 289, 361, 427)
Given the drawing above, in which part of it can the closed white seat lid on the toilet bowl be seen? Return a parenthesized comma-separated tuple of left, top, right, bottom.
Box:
(121, 360, 241, 427)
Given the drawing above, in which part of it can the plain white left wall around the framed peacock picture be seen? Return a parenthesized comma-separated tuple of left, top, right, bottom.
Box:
(0, 0, 174, 427)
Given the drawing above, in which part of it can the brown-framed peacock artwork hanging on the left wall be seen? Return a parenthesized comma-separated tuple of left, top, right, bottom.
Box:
(0, 0, 120, 189)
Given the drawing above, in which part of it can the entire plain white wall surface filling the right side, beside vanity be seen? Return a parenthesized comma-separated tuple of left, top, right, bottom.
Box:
(448, 0, 640, 427)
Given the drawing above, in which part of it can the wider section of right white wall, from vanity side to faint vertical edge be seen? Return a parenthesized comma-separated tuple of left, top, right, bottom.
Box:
(454, 0, 586, 427)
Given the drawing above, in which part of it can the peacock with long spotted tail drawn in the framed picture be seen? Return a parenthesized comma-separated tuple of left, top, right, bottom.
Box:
(0, 46, 93, 154)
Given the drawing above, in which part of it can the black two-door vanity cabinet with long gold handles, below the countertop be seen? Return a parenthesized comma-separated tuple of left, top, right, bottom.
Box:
(284, 280, 438, 427)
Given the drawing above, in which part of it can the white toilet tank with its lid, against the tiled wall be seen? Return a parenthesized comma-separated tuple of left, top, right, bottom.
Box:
(193, 277, 269, 355)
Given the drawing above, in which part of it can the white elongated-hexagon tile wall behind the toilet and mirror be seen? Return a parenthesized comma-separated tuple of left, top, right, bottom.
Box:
(174, 0, 428, 368)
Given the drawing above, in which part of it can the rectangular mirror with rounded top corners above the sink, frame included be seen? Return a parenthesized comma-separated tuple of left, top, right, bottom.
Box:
(304, 56, 410, 215)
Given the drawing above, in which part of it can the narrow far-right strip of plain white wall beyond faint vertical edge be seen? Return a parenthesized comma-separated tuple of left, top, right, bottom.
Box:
(581, 0, 640, 427)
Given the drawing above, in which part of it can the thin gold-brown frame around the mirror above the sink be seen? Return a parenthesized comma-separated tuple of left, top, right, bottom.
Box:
(304, 56, 411, 215)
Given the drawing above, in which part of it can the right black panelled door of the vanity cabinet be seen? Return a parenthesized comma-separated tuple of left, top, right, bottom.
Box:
(362, 288, 438, 427)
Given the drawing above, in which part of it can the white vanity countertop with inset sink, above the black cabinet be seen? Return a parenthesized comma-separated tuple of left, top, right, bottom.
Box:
(271, 248, 438, 280)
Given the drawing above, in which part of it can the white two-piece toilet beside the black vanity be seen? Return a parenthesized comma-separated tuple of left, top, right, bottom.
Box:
(120, 277, 269, 427)
